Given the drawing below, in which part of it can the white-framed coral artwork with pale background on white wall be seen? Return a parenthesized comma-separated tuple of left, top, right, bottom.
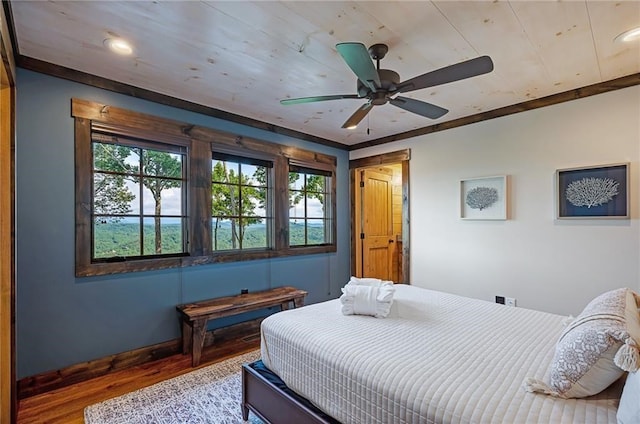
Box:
(460, 175, 507, 220)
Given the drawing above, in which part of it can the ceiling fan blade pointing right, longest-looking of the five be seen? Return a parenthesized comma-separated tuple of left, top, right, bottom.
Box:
(395, 56, 493, 93)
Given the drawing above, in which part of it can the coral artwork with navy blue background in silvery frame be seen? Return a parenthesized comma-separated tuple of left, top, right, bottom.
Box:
(556, 163, 629, 219)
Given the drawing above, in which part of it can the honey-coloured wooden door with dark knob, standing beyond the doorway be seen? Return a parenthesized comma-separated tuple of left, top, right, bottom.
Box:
(360, 169, 395, 280)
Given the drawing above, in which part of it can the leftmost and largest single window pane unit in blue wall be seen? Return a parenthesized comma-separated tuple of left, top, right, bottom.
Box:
(92, 137, 187, 261)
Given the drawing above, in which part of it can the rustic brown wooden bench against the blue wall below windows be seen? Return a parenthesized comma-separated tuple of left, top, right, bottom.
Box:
(176, 287, 307, 367)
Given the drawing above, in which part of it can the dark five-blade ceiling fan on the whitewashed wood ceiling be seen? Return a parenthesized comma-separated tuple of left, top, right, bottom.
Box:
(280, 43, 493, 129)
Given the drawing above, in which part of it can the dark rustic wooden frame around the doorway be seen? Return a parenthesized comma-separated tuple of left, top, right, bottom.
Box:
(349, 149, 411, 284)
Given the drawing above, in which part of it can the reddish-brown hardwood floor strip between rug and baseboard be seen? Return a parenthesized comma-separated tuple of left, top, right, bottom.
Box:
(17, 326, 260, 424)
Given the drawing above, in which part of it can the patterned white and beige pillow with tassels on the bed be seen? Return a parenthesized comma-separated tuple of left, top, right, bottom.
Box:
(525, 288, 640, 398)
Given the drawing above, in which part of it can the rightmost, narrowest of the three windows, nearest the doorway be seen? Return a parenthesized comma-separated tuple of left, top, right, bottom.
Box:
(289, 165, 332, 247)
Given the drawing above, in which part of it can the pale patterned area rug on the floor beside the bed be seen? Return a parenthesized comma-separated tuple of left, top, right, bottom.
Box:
(84, 350, 262, 424)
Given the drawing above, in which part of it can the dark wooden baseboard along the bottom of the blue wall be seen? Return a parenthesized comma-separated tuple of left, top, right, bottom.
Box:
(17, 318, 263, 399)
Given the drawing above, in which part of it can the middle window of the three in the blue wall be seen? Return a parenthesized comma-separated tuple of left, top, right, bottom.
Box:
(211, 153, 273, 251)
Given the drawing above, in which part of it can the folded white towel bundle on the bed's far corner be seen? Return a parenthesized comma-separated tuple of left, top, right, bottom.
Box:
(340, 282, 396, 318)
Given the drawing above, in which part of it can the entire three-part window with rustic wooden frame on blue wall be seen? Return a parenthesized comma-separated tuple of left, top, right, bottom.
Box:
(72, 99, 336, 277)
